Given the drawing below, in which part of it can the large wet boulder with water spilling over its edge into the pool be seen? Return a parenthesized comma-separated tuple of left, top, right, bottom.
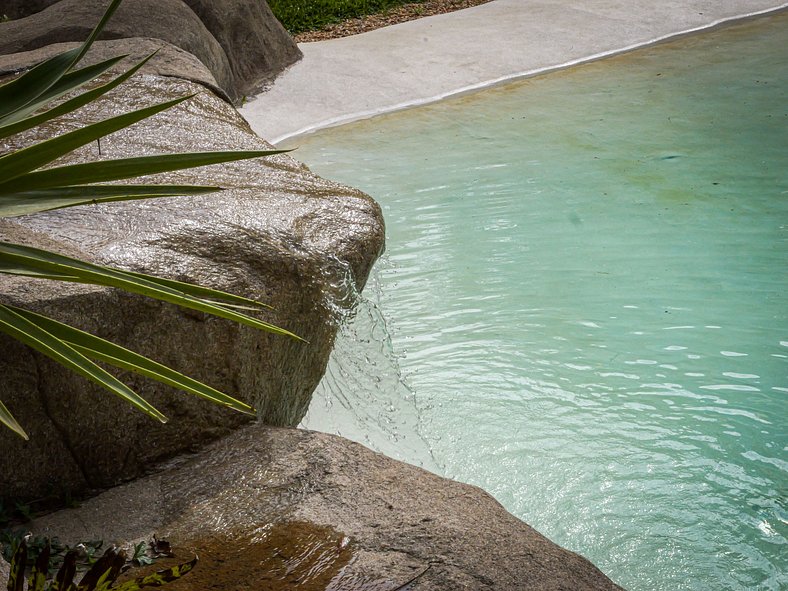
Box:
(0, 75, 383, 499)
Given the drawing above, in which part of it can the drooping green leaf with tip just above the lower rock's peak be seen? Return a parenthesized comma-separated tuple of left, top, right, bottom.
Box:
(8, 306, 255, 415)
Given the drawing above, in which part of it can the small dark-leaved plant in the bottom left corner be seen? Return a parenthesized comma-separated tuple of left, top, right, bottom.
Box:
(7, 539, 197, 591)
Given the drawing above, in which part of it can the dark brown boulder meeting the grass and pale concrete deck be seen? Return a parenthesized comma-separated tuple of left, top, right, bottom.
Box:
(185, 0, 301, 95)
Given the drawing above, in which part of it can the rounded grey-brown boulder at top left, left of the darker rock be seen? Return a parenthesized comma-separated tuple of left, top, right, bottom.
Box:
(0, 0, 239, 99)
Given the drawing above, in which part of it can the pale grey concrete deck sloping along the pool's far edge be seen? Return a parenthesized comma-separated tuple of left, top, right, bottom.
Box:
(240, 0, 788, 144)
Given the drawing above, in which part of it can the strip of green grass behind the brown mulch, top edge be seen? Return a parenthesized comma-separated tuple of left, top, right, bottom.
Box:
(268, 0, 424, 35)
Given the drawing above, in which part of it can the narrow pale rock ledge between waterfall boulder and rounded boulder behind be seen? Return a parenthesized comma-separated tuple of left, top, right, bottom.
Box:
(0, 37, 230, 102)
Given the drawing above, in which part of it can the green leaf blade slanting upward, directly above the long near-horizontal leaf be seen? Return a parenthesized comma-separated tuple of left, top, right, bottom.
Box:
(0, 95, 193, 187)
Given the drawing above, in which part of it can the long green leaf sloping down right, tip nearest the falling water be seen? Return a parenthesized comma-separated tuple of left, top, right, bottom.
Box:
(0, 242, 303, 341)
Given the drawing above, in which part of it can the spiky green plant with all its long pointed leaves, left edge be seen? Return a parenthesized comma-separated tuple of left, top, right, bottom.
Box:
(0, 0, 299, 438)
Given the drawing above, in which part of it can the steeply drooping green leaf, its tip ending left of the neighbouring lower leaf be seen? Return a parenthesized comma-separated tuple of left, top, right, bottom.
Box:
(0, 304, 167, 432)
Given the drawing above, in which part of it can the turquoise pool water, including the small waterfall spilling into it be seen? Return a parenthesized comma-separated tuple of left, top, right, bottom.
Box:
(286, 15, 788, 591)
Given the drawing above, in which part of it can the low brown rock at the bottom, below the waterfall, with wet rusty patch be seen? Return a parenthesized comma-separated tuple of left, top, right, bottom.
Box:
(16, 425, 620, 591)
